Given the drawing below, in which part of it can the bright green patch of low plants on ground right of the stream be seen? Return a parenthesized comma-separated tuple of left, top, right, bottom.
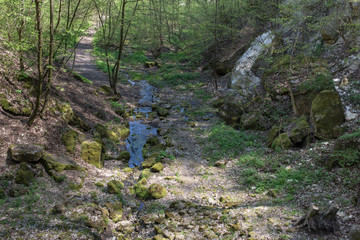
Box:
(204, 124, 261, 161)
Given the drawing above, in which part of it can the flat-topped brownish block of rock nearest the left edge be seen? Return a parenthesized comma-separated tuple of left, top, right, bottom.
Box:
(9, 144, 45, 163)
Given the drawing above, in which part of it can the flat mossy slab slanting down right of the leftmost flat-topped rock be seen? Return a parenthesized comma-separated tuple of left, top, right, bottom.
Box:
(40, 153, 82, 172)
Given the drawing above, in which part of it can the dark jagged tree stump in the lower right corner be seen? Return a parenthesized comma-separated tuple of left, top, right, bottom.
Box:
(295, 203, 339, 232)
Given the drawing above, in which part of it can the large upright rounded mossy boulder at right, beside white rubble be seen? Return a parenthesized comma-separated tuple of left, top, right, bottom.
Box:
(310, 90, 345, 139)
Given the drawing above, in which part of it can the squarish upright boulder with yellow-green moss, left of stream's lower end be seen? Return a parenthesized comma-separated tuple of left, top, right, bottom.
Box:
(81, 140, 105, 168)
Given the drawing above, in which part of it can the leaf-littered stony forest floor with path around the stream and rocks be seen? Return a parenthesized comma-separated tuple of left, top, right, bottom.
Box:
(0, 29, 360, 239)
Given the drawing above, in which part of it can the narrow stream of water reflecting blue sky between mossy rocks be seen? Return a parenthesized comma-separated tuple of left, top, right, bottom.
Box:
(126, 80, 157, 168)
